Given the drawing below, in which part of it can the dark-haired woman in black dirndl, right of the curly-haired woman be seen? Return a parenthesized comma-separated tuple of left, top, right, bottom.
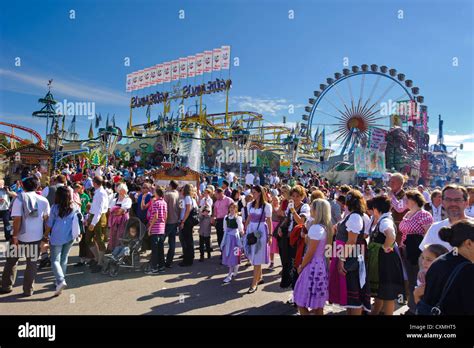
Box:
(368, 196, 405, 315)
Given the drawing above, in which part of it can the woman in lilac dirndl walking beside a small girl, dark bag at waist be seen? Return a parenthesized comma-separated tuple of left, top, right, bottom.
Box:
(243, 185, 272, 294)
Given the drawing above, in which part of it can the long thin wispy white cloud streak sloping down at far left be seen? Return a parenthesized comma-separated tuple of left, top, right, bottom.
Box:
(0, 69, 130, 106)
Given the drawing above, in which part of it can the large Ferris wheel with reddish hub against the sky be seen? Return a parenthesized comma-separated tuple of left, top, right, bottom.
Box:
(299, 64, 424, 156)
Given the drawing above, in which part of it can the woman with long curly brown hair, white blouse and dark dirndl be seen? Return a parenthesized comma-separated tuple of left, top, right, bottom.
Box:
(329, 190, 371, 315)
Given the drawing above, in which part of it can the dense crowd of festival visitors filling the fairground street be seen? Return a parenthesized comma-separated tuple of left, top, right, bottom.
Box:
(0, 162, 474, 315)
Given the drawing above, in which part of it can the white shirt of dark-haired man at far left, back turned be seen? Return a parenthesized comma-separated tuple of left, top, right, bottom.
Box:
(11, 192, 50, 243)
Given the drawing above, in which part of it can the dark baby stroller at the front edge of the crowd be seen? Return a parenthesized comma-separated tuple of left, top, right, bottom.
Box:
(102, 217, 146, 277)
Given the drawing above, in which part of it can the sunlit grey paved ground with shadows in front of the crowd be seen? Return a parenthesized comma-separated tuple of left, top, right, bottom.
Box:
(0, 226, 405, 315)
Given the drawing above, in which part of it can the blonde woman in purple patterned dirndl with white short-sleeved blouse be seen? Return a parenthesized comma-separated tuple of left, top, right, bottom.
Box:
(293, 198, 332, 315)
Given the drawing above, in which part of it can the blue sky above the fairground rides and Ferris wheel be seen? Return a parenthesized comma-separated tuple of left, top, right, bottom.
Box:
(0, 0, 474, 165)
